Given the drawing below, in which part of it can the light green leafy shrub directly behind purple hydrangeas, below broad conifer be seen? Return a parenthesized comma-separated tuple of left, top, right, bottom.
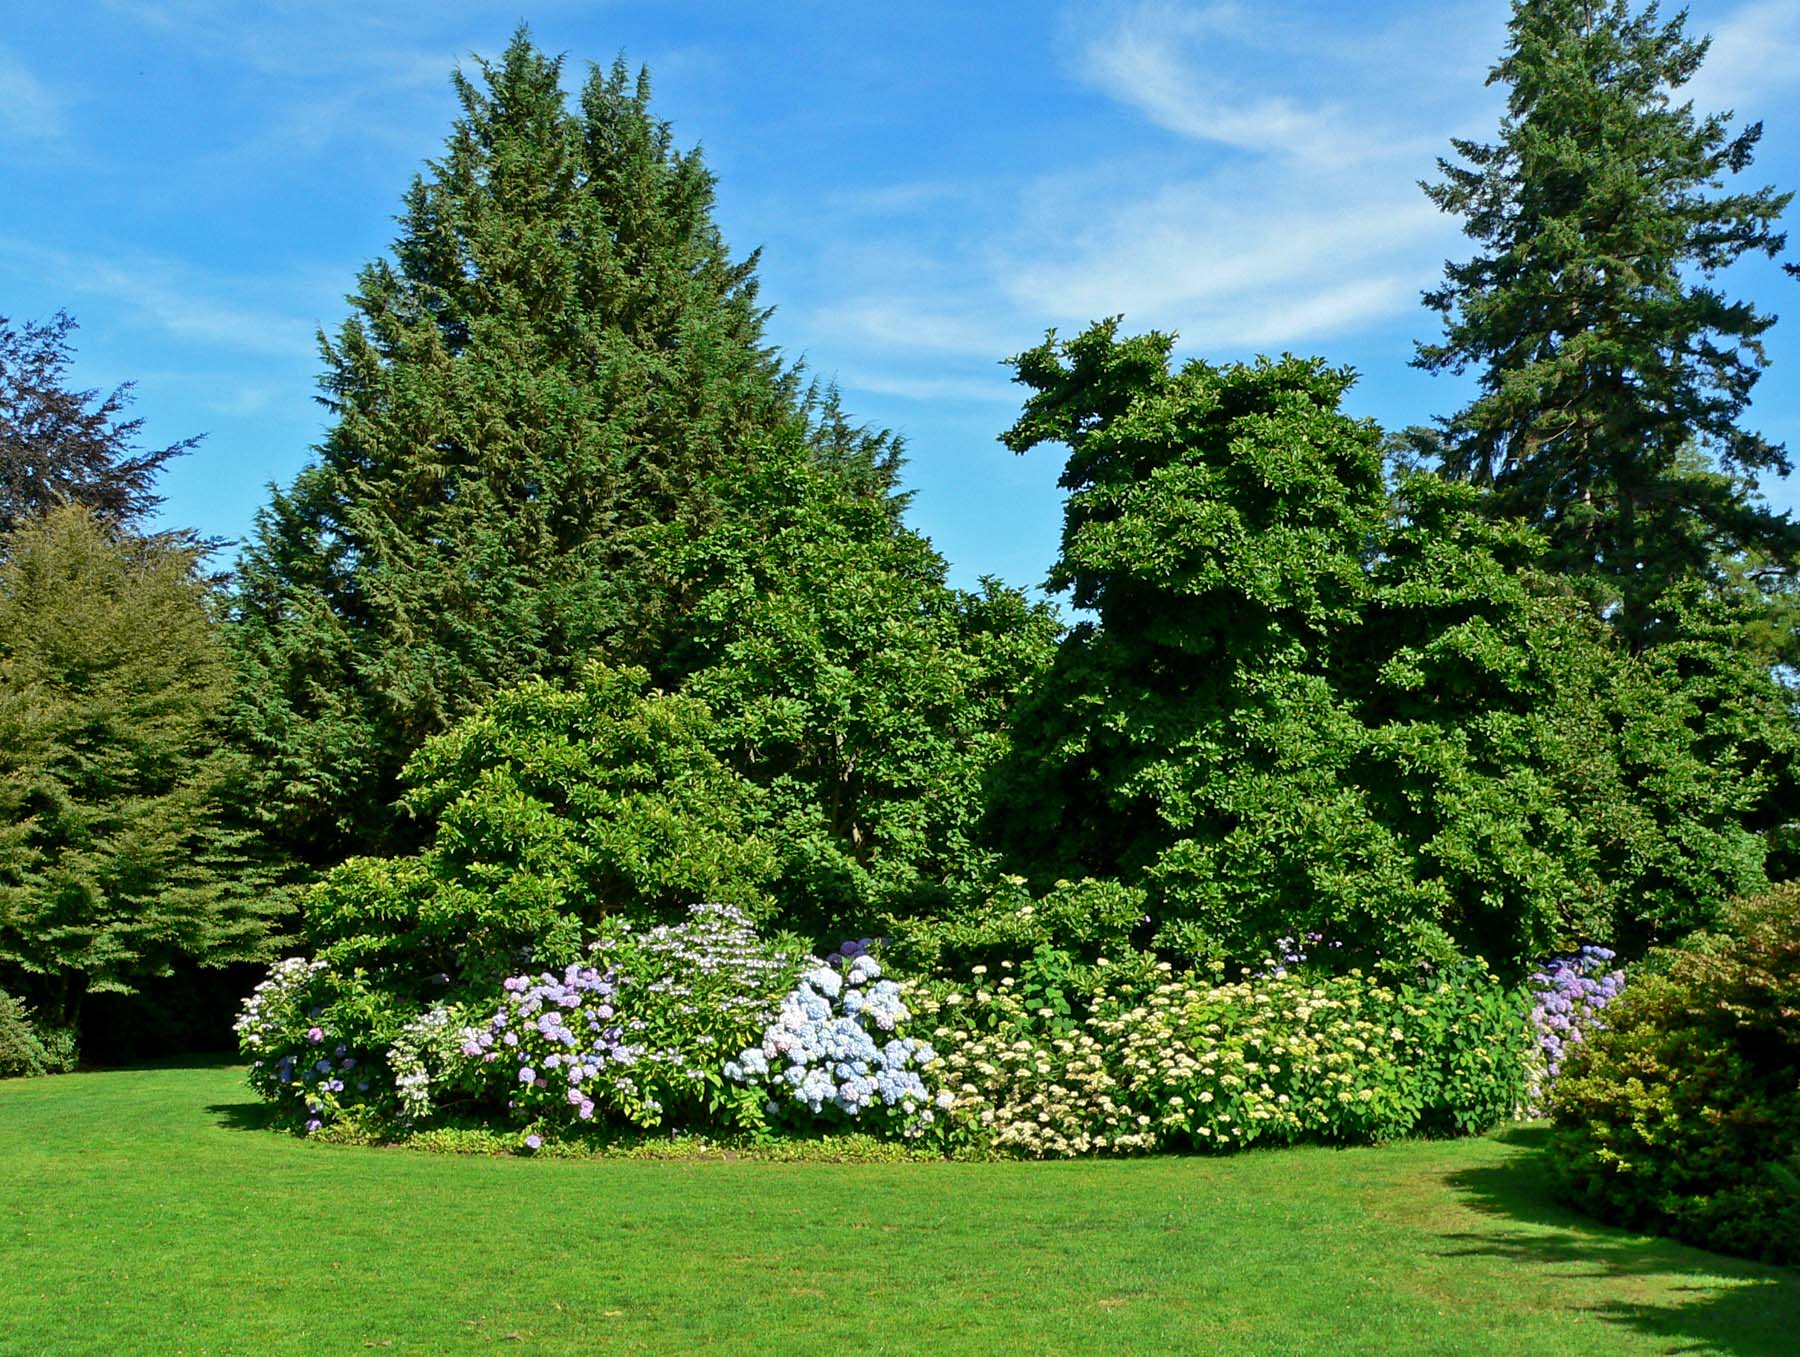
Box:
(306, 664, 776, 1013)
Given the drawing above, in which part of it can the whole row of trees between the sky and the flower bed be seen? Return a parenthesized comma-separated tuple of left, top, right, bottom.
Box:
(0, 0, 1800, 1067)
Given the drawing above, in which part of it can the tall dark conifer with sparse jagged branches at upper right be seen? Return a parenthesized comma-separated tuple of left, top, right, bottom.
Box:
(1415, 0, 1800, 644)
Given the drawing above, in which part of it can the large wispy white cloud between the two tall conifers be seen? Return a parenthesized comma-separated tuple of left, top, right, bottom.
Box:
(806, 0, 1501, 376)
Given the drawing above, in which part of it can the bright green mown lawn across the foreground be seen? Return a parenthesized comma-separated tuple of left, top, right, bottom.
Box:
(0, 1067, 1800, 1357)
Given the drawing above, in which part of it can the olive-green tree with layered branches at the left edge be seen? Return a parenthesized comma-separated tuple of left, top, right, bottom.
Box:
(0, 506, 274, 1029)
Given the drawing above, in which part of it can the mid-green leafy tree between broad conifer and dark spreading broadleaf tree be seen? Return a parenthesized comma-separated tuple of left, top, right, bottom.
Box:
(655, 436, 1057, 938)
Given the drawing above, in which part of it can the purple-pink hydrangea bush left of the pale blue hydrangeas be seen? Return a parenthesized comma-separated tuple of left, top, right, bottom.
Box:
(461, 965, 644, 1125)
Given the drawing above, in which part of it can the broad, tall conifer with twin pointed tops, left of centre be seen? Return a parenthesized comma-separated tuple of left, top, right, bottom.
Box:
(236, 29, 896, 862)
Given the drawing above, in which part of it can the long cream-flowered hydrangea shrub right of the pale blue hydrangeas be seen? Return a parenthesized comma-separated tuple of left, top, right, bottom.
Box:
(914, 963, 1526, 1157)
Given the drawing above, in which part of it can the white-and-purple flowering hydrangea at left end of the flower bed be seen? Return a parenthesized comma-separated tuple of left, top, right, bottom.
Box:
(232, 957, 371, 1132)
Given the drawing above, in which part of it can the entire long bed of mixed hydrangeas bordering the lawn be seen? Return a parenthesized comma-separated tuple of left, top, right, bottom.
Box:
(238, 903, 1534, 1157)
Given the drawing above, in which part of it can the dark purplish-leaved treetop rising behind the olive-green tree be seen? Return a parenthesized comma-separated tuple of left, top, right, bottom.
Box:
(0, 311, 200, 533)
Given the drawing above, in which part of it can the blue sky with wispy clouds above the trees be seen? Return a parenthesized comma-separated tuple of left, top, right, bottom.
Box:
(0, 0, 1800, 585)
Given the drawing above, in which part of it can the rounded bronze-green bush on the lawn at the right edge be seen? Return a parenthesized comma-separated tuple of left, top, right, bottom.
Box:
(1552, 884, 1800, 1262)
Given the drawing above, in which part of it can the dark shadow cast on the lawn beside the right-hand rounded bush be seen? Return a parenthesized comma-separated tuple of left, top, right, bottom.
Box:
(1442, 1127, 1800, 1357)
